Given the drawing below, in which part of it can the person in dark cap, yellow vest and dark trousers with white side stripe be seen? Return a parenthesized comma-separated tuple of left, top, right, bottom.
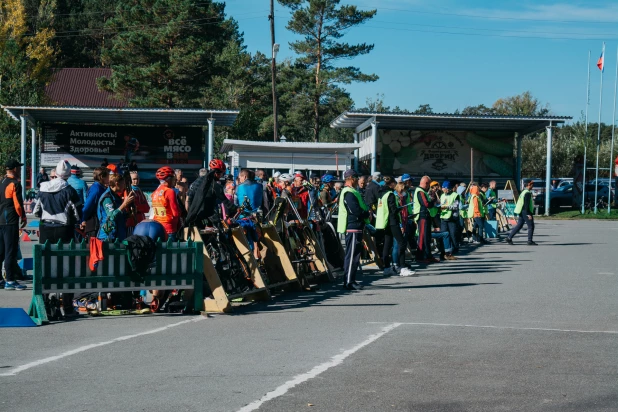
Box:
(337, 169, 369, 290)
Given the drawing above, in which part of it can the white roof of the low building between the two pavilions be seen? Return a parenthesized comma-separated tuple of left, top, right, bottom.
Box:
(221, 139, 361, 153)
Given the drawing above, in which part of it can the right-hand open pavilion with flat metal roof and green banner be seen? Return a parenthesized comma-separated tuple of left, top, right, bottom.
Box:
(331, 111, 571, 181)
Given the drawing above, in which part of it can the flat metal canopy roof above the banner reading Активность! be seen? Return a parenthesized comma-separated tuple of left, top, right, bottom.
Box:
(1, 106, 239, 126)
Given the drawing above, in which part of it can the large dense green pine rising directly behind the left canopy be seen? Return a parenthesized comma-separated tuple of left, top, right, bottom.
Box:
(99, 0, 242, 107)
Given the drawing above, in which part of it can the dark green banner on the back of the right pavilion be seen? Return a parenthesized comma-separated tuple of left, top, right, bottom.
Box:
(378, 130, 515, 179)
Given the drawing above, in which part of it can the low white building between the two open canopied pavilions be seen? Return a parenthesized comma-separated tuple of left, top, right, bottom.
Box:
(221, 139, 361, 176)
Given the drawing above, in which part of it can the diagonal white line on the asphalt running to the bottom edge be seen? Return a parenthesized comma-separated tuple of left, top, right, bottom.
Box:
(238, 323, 401, 412)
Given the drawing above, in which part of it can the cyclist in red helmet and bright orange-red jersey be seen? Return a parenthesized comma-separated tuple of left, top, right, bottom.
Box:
(151, 166, 180, 241)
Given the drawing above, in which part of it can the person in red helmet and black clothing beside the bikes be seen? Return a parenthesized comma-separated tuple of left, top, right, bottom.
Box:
(185, 159, 236, 227)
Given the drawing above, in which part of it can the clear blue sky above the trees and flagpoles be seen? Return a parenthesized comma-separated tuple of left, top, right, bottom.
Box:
(226, 0, 618, 123)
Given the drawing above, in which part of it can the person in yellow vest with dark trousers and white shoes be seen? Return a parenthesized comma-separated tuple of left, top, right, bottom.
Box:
(376, 176, 414, 276)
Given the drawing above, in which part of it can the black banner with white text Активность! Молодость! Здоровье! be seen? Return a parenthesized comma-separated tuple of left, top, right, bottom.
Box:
(41, 124, 204, 168)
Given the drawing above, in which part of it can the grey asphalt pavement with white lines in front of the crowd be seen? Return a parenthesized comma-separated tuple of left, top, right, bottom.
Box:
(0, 221, 618, 412)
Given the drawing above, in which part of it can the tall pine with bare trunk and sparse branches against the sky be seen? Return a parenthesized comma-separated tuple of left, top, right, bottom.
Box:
(279, 0, 378, 142)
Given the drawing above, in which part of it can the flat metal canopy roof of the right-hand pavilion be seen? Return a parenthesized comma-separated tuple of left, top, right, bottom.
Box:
(330, 111, 572, 134)
